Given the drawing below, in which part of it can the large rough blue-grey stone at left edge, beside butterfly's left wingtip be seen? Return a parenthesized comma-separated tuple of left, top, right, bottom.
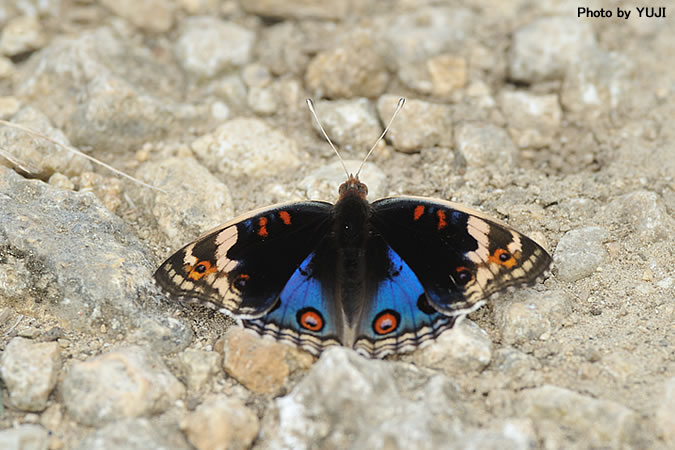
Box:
(0, 167, 154, 332)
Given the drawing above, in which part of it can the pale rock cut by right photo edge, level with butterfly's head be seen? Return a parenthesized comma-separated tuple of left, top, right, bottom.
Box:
(601, 191, 675, 242)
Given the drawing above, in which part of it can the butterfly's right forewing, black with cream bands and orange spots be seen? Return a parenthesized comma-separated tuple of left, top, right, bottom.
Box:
(371, 197, 551, 316)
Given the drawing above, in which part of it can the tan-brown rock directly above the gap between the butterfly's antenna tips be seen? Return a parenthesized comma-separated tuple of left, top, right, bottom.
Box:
(305, 32, 396, 99)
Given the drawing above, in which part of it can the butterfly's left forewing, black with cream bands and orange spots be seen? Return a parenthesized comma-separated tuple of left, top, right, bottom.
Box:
(155, 202, 333, 319)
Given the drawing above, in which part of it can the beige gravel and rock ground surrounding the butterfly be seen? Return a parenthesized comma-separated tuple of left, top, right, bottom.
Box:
(0, 0, 675, 450)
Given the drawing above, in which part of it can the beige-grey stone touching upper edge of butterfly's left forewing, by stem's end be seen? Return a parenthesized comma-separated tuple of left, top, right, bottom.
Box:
(136, 157, 234, 249)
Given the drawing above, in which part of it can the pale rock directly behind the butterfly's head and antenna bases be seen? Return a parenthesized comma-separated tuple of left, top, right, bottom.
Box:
(301, 159, 387, 203)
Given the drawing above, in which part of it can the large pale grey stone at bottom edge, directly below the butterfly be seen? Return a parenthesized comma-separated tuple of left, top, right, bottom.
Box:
(262, 347, 469, 449)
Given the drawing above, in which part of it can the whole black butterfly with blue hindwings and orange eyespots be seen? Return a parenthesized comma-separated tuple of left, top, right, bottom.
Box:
(154, 101, 551, 358)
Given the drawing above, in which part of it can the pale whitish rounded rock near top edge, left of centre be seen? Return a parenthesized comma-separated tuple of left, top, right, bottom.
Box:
(175, 16, 255, 78)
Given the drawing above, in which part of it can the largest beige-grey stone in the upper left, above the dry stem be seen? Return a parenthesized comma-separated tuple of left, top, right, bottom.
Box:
(17, 28, 189, 153)
